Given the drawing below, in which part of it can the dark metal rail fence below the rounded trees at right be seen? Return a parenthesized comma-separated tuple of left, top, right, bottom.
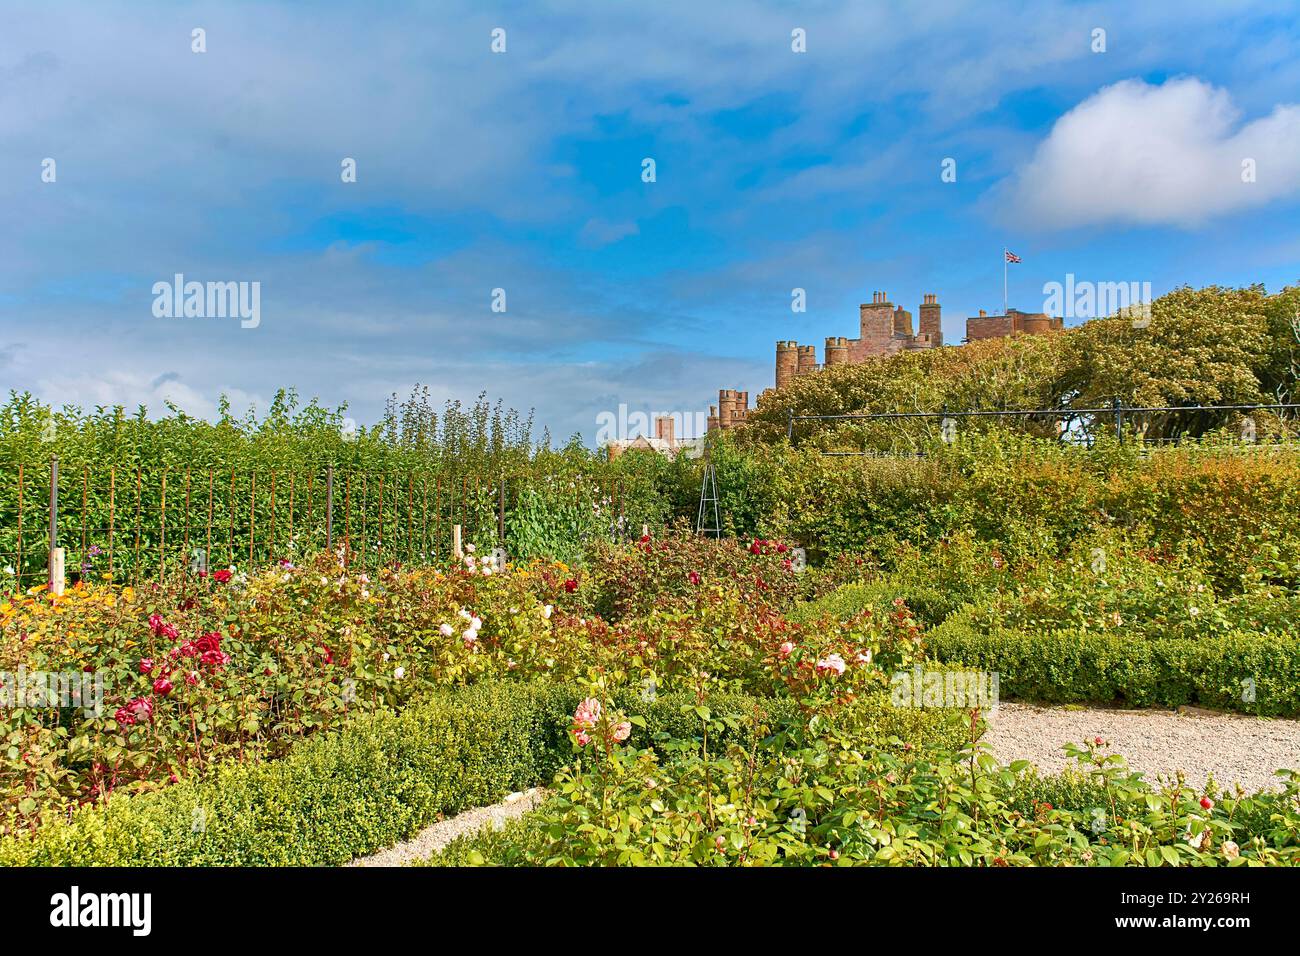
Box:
(787, 402, 1300, 458)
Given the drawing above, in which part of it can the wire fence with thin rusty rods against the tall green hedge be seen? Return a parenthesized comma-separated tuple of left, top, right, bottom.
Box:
(0, 458, 624, 593)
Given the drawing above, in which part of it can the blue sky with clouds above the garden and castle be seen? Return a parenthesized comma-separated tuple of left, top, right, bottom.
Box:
(0, 0, 1300, 440)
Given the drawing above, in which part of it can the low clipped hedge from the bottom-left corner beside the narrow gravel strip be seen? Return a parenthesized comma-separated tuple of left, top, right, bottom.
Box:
(0, 683, 961, 866)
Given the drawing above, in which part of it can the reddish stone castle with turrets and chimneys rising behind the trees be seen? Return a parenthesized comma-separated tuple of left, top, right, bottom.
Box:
(709, 293, 1063, 432)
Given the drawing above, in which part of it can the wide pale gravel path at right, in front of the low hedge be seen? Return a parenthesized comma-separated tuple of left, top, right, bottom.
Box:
(985, 702, 1300, 791)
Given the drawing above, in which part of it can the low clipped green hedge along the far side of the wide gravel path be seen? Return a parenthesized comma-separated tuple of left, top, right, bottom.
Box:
(926, 620, 1300, 717)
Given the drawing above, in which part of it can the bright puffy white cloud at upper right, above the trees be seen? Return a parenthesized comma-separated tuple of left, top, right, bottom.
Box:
(996, 78, 1300, 229)
